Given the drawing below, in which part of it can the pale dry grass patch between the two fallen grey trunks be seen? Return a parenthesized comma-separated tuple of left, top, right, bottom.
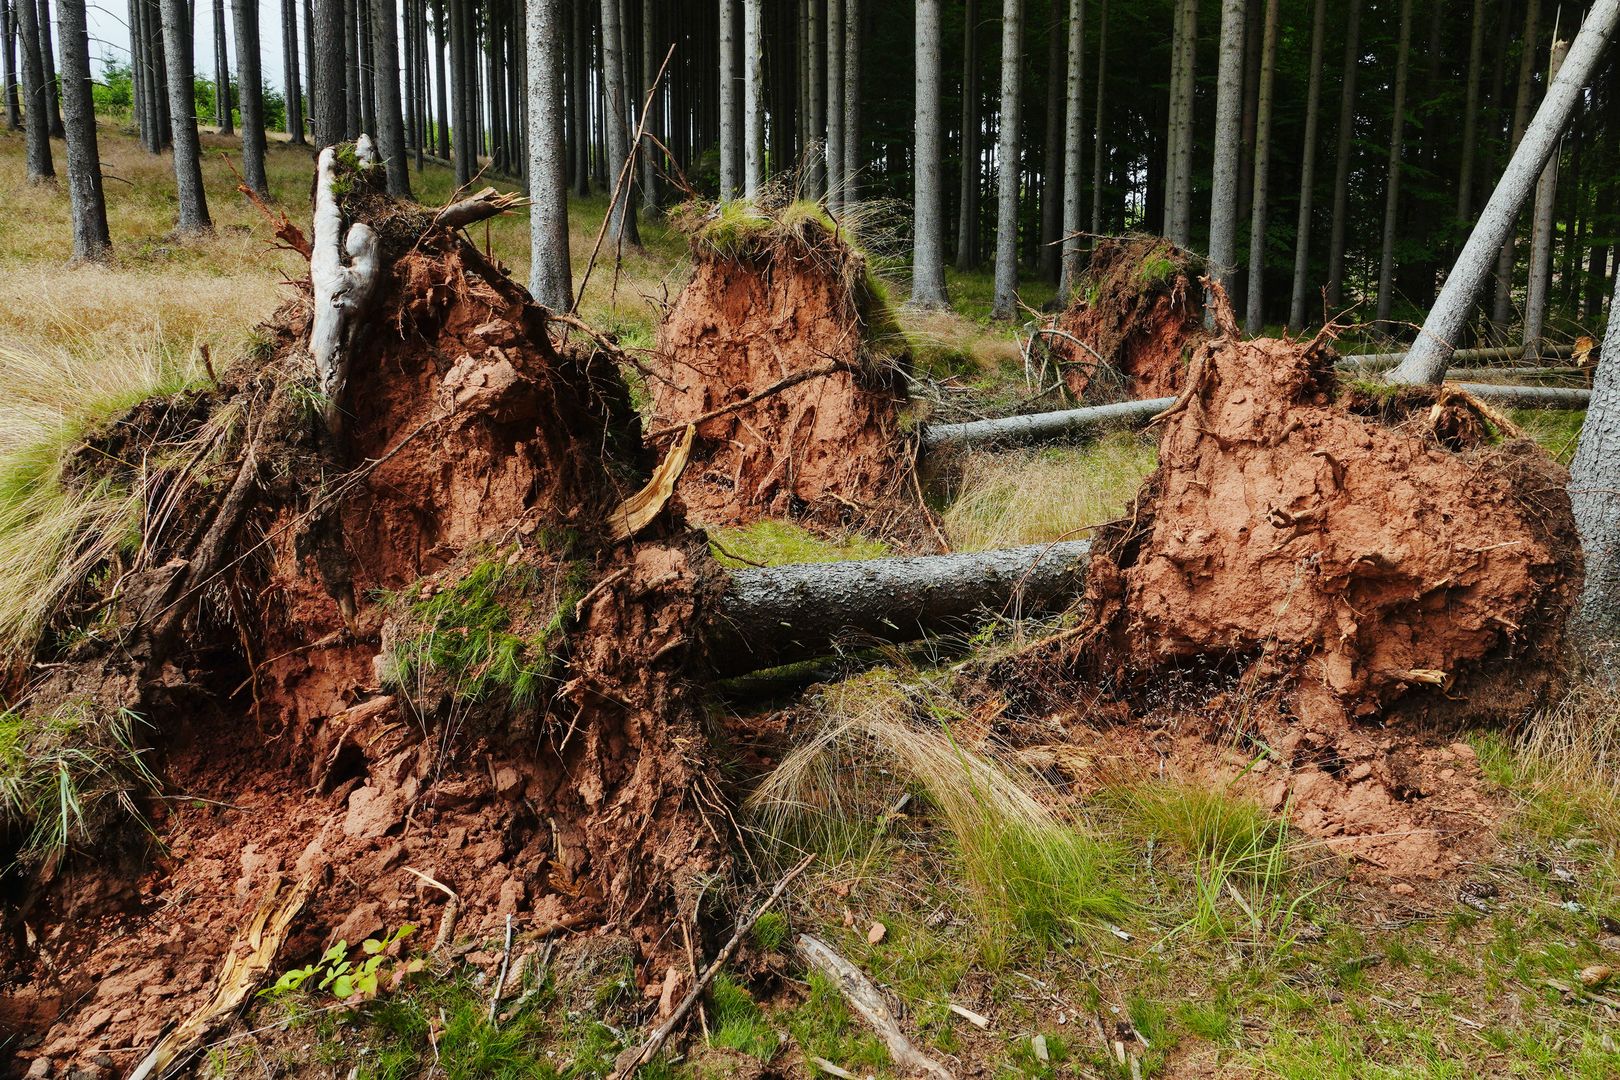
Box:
(941, 432, 1158, 551)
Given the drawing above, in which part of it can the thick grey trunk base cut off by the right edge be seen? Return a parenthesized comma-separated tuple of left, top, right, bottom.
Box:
(1570, 263, 1620, 667)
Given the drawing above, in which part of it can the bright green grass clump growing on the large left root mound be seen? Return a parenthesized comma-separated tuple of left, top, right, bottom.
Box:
(390, 559, 585, 708)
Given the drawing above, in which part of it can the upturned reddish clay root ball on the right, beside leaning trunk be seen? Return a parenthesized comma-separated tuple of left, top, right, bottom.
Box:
(1004, 298, 1581, 874)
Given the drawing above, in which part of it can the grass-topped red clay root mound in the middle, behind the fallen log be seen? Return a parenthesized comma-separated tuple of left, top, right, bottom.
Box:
(650, 204, 912, 525)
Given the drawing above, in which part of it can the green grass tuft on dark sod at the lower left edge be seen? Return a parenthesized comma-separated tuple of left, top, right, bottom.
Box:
(0, 701, 157, 863)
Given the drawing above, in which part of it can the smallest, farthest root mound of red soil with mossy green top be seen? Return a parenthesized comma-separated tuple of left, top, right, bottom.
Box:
(1050, 236, 1209, 403)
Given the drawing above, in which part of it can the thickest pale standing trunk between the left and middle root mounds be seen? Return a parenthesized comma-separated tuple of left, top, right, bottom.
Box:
(527, 0, 573, 311)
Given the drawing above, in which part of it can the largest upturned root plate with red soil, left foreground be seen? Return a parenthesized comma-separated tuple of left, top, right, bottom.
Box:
(0, 156, 727, 1070)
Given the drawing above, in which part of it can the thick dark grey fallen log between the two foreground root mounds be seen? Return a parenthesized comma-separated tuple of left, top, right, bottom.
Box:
(706, 541, 1090, 675)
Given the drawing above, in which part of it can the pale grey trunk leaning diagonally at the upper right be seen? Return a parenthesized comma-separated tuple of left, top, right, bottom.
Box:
(1393, 0, 1620, 382)
